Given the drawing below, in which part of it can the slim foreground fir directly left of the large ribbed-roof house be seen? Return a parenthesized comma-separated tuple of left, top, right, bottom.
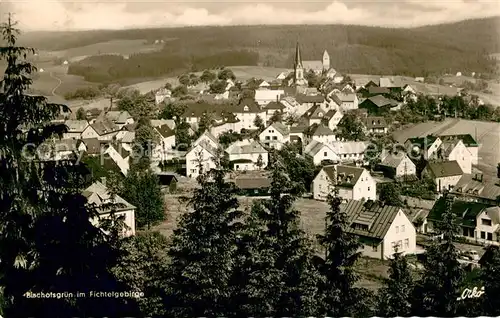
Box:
(318, 190, 368, 316)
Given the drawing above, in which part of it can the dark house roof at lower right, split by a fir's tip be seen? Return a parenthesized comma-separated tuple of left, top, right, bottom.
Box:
(427, 197, 492, 227)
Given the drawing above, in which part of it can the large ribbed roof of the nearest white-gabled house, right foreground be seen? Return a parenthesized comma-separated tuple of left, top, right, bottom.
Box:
(344, 200, 404, 240)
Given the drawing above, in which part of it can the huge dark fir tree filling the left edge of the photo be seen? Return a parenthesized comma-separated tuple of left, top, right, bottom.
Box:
(0, 16, 139, 317)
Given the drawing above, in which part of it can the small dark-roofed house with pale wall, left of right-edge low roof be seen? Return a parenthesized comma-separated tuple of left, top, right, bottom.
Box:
(422, 161, 464, 192)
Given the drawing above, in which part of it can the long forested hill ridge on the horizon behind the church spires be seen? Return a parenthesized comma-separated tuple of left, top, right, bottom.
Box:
(22, 17, 500, 80)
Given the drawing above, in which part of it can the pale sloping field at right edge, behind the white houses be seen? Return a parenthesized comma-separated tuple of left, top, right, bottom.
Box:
(394, 119, 500, 175)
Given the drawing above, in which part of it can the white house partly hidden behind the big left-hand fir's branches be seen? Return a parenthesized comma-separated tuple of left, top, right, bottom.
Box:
(83, 181, 135, 236)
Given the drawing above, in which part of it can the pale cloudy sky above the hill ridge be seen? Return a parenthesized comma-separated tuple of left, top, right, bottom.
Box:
(0, 0, 500, 31)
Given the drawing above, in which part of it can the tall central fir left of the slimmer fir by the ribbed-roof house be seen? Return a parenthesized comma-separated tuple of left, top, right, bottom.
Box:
(254, 161, 319, 316)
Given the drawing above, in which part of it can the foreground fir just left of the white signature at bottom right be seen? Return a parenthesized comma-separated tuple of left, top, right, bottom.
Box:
(413, 194, 464, 317)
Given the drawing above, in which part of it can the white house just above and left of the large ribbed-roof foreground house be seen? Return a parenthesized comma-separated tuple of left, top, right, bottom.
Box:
(312, 165, 377, 200)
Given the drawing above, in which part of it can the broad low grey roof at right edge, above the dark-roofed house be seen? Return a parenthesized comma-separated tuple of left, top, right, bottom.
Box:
(451, 173, 500, 205)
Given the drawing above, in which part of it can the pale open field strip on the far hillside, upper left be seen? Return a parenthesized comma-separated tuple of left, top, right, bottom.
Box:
(40, 40, 162, 62)
